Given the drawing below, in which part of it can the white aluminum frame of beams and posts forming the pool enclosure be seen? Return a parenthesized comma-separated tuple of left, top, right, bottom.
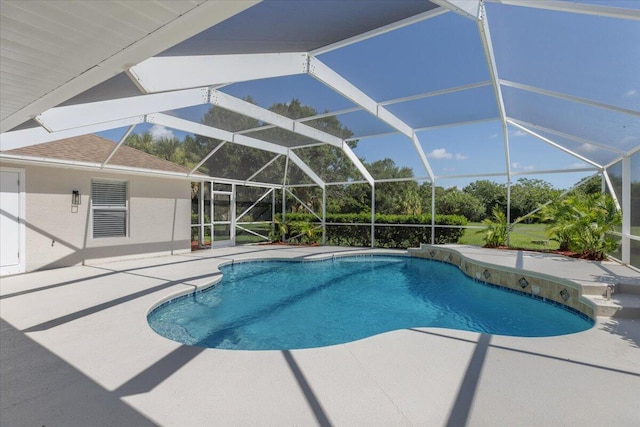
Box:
(0, 0, 640, 263)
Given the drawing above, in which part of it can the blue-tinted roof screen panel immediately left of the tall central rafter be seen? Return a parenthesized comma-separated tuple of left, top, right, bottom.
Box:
(319, 13, 489, 102)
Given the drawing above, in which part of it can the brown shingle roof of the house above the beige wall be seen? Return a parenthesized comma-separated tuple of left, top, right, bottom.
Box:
(5, 135, 189, 173)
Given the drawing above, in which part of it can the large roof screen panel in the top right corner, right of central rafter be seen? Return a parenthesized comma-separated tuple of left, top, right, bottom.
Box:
(486, 1, 640, 111)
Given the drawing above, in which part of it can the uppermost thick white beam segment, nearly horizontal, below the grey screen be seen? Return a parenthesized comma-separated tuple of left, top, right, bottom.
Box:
(127, 52, 308, 93)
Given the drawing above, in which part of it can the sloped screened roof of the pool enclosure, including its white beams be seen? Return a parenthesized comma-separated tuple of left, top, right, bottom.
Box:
(1, 0, 640, 191)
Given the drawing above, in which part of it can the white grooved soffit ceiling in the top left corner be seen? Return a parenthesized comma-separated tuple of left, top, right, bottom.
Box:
(0, 0, 256, 132)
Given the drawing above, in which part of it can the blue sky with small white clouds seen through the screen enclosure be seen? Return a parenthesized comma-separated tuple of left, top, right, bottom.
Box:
(103, 0, 640, 188)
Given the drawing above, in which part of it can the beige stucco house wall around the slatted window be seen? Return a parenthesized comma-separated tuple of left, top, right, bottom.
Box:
(2, 162, 191, 271)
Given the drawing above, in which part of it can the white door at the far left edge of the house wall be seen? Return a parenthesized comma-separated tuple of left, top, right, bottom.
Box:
(0, 170, 24, 275)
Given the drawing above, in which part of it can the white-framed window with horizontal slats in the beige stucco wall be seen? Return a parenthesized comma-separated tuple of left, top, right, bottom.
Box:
(91, 181, 128, 238)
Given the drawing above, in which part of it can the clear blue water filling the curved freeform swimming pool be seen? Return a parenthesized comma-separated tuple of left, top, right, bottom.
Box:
(148, 256, 593, 350)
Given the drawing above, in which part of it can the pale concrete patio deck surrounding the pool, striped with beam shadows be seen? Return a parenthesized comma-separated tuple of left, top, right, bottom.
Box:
(0, 246, 640, 427)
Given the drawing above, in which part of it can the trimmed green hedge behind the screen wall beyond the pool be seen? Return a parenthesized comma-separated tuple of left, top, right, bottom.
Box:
(276, 213, 467, 249)
